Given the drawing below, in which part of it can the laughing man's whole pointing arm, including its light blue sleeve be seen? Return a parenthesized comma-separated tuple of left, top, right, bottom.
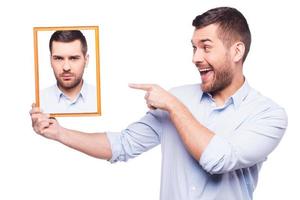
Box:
(129, 84, 287, 174)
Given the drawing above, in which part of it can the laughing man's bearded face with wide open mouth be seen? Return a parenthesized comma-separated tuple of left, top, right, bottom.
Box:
(192, 24, 234, 94)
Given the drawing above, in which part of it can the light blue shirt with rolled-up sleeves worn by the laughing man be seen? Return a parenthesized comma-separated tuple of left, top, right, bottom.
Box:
(107, 81, 287, 200)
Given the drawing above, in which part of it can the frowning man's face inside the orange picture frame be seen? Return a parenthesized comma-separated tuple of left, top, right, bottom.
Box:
(51, 40, 88, 90)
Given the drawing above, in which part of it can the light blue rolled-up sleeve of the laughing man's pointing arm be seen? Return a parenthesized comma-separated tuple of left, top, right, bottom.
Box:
(199, 108, 287, 174)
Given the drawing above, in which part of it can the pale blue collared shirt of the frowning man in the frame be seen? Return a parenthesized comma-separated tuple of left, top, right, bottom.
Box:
(40, 81, 97, 113)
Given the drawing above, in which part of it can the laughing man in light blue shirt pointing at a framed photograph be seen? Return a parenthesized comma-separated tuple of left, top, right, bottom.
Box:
(31, 7, 287, 200)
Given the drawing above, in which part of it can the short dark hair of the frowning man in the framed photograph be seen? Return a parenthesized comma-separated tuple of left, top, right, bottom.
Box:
(49, 30, 87, 56)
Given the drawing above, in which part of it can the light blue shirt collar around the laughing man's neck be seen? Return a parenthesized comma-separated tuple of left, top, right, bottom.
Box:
(200, 78, 250, 108)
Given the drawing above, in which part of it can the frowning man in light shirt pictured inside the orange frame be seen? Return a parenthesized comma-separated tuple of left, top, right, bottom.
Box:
(40, 30, 97, 113)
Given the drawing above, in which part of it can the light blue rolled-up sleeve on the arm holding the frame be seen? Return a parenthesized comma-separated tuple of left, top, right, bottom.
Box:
(106, 109, 162, 163)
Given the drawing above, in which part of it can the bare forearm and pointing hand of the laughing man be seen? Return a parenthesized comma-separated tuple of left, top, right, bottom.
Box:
(129, 84, 215, 160)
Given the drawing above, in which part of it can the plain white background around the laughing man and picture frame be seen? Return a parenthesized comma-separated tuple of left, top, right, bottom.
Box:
(0, 0, 300, 200)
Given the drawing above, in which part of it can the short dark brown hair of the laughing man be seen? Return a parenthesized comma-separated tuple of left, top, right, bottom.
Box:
(193, 7, 251, 62)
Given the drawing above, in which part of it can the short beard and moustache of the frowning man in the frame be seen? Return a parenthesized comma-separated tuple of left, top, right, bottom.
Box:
(55, 72, 82, 90)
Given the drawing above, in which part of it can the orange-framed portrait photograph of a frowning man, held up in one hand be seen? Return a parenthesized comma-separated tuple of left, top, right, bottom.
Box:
(33, 26, 101, 117)
